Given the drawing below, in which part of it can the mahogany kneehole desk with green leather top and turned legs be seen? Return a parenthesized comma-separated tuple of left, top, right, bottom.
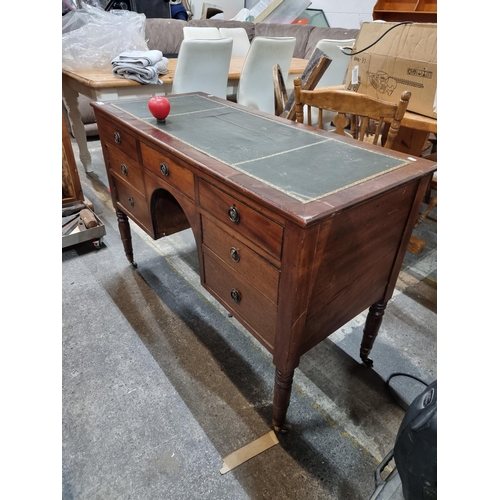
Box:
(92, 93, 435, 430)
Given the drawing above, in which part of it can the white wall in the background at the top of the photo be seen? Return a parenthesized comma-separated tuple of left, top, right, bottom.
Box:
(191, 0, 376, 28)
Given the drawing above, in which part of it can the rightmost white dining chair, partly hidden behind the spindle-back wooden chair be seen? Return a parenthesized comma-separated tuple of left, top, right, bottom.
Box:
(305, 38, 356, 125)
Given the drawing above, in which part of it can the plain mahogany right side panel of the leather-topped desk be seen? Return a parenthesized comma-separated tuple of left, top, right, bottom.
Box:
(300, 180, 419, 353)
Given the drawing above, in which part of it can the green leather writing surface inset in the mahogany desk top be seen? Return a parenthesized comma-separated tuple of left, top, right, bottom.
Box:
(113, 95, 409, 203)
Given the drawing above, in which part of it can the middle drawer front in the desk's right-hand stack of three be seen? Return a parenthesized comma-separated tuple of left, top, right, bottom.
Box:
(202, 217, 280, 304)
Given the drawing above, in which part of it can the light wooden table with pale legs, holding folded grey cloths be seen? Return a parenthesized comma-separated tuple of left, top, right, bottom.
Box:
(62, 57, 308, 171)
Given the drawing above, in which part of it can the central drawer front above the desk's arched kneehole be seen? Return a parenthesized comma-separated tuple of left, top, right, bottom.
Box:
(141, 143, 194, 200)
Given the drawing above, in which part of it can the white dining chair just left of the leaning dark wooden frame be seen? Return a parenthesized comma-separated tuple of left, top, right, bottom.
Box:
(236, 36, 296, 115)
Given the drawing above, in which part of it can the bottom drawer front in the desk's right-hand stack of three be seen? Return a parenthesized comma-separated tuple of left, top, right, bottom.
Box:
(203, 248, 277, 352)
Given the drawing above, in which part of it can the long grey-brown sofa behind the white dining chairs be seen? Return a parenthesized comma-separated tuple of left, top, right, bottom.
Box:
(63, 18, 359, 137)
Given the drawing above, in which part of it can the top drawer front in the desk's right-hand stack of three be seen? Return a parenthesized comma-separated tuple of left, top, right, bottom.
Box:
(199, 179, 283, 260)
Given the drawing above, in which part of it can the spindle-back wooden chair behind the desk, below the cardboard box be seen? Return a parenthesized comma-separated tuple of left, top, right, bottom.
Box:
(294, 78, 411, 149)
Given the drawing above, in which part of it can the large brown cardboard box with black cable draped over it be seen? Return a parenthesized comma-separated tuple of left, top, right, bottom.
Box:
(346, 22, 437, 118)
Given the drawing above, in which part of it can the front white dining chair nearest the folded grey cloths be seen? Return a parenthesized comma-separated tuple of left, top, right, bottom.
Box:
(172, 38, 233, 99)
